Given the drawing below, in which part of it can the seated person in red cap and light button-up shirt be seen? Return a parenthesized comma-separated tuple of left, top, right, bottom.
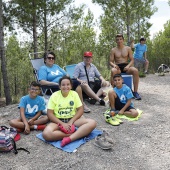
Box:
(73, 51, 106, 106)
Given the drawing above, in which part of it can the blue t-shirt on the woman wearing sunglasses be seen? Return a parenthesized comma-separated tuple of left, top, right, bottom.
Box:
(38, 64, 67, 83)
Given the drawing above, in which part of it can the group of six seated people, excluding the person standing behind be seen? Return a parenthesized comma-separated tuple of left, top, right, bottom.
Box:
(9, 34, 147, 147)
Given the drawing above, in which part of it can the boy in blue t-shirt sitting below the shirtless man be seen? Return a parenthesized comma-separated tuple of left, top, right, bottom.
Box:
(109, 74, 138, 118)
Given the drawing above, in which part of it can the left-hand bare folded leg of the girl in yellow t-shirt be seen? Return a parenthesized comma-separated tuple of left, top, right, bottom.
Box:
(42, 123, 70, 141)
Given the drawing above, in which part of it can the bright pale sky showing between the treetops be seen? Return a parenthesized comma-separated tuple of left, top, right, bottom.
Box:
(75, 0, 170, 38)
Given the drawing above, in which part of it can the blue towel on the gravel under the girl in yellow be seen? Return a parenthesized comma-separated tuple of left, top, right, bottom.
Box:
(36, 129, 103, 152)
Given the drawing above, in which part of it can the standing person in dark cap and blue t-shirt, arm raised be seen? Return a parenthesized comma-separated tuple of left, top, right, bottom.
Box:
(131, 38, 149, 74)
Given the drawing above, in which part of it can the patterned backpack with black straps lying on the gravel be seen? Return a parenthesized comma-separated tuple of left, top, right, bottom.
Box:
(0, 126, 30, 154)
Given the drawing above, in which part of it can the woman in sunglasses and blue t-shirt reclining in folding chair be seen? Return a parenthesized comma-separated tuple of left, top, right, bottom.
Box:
(38, 52, 90, 113)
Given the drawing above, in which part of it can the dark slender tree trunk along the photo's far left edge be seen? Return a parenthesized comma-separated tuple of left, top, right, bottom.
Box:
(0, 0, 12, 105)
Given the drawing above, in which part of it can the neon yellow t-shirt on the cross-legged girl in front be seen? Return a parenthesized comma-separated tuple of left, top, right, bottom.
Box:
(48, 90, 82, 119)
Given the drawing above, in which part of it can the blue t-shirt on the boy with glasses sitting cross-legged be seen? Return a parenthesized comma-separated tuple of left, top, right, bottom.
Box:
(18, 95, 45, 118)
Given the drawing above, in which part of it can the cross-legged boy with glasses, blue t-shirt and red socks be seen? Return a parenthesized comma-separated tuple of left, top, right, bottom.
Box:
(9, 81, 48, 134)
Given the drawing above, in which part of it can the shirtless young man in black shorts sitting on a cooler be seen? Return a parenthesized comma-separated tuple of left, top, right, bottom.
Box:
(110, 34, 141, 100)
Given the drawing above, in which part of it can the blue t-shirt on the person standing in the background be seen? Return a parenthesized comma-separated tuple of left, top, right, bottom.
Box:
(133, 43, 147, 60)
